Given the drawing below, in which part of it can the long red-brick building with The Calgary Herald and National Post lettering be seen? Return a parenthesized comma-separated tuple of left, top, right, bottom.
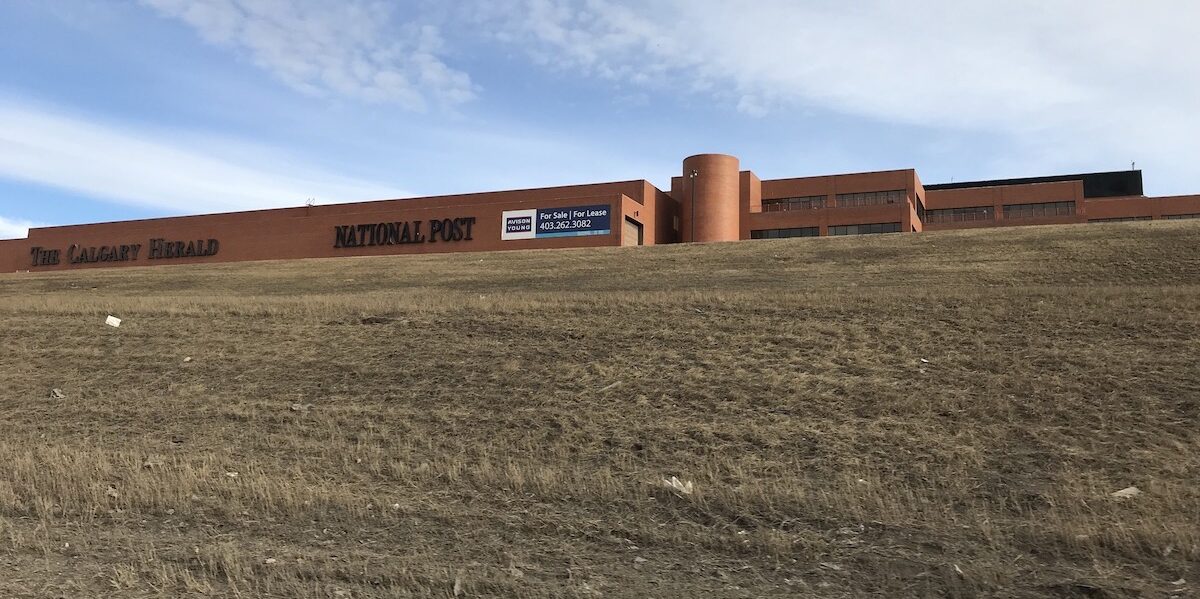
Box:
(0, 154, 1200, 272)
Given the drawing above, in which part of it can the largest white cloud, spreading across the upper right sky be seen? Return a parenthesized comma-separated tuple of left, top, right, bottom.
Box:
(470, 0, 1200, 184)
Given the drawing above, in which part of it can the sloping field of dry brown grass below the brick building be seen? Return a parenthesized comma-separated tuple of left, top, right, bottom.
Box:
(0, 221, 1200, 598)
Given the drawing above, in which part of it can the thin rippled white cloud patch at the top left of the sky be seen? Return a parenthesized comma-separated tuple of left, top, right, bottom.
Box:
(140, 0, 475, 110)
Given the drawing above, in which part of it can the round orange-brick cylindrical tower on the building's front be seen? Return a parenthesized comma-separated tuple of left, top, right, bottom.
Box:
(676, 154, 742, 241)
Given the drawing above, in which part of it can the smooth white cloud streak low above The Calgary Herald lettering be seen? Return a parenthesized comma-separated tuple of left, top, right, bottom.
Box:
(0, 100, 407, 214)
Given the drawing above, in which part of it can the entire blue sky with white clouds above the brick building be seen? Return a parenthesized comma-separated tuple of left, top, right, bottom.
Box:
(0, 0, 1200, 238)
